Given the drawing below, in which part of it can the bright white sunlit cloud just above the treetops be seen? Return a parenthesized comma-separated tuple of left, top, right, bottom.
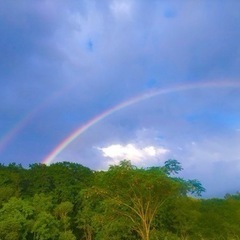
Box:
(98, 144, 169, 165)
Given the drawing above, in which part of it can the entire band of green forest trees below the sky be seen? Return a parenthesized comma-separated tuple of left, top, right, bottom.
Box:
(0, 159, 240, 240)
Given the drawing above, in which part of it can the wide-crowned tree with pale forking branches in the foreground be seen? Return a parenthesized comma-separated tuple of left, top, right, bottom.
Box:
(81, 160, 184, 240)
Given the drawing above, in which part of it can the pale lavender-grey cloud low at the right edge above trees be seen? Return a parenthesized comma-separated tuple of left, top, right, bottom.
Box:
(170, 133, 240, 197)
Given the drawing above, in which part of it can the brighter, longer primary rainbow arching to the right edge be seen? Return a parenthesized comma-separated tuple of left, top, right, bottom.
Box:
(42, 80, 240, 165)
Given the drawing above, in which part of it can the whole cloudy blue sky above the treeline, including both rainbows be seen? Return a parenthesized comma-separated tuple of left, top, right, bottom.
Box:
(0, 0, 240, 197)
